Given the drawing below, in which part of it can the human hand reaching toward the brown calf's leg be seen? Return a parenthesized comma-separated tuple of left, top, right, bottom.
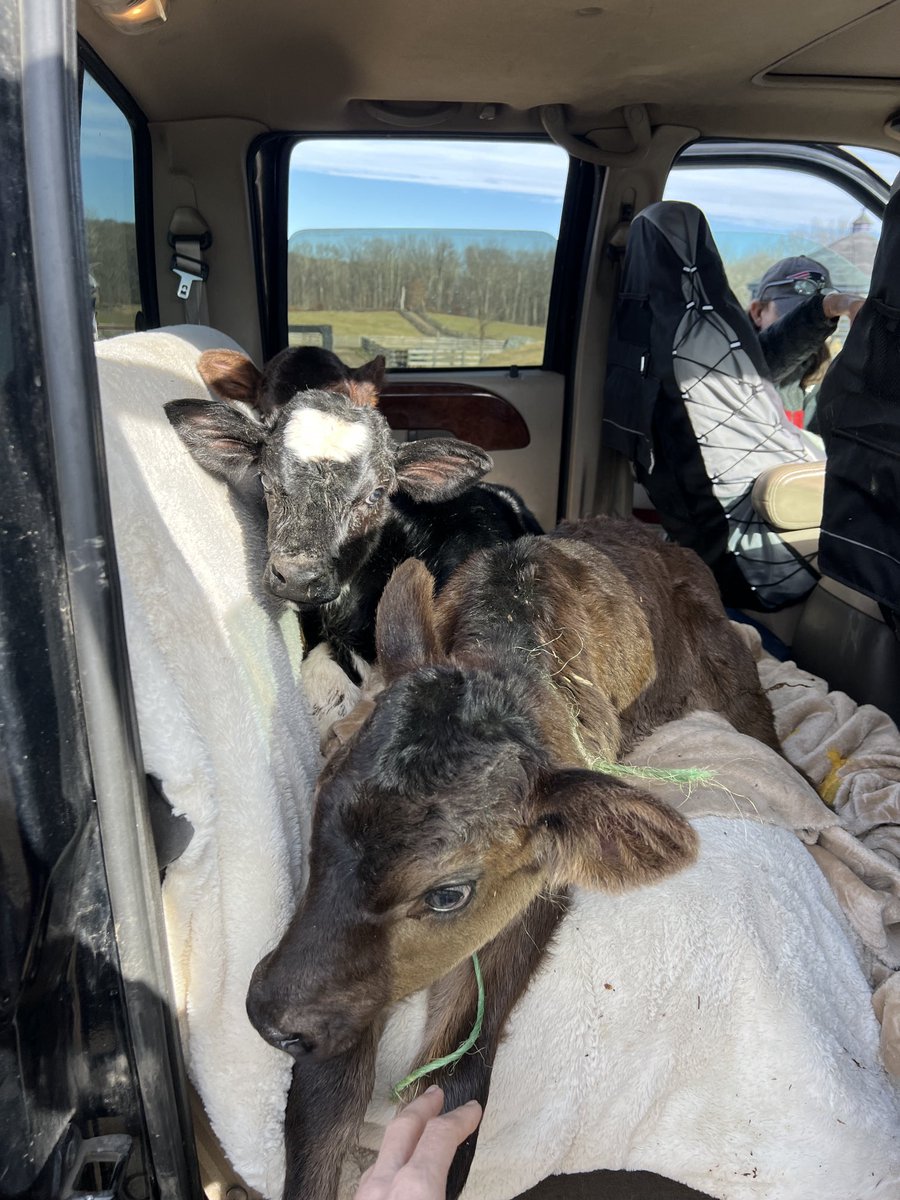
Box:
(354, 1087, 481, 1200)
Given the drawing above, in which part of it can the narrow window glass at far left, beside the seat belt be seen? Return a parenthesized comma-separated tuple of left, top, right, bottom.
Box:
(80, 71, 140, 337)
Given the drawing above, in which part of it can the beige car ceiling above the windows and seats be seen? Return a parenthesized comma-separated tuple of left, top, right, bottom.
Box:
(78, 0, 900, 149)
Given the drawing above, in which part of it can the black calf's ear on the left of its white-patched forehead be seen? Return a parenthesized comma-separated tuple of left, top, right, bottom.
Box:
(166, 400, 265, 488)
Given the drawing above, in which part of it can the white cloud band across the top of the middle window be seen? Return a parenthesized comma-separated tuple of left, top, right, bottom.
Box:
(290, 138, 569, 203)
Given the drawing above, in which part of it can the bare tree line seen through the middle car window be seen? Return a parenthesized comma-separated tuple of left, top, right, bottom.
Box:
(288, 236, 554, 325)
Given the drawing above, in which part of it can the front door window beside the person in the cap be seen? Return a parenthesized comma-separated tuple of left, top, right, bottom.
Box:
(665, 166, 881, 307)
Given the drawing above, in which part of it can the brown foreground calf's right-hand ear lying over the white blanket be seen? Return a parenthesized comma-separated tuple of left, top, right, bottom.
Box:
(533, 769, 697, 892)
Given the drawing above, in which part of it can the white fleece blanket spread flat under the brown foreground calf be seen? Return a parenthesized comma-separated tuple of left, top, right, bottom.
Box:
(343, 820, 900, 1200)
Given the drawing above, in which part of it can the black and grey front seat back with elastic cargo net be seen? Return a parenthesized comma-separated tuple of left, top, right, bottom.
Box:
(604, 202, 822, 608)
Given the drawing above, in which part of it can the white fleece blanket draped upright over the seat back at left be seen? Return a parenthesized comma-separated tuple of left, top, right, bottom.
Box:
(97, 326, 319, 1195)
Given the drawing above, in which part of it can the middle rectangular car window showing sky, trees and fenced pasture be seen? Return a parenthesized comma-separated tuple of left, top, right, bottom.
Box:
(288, 138, 569, 370)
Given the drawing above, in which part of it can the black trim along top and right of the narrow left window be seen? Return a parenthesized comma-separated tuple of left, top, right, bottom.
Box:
(78, 34, 160, 329)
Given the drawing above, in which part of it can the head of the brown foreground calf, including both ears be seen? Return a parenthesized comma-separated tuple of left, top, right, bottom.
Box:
(247, 560, 695, 1058)
